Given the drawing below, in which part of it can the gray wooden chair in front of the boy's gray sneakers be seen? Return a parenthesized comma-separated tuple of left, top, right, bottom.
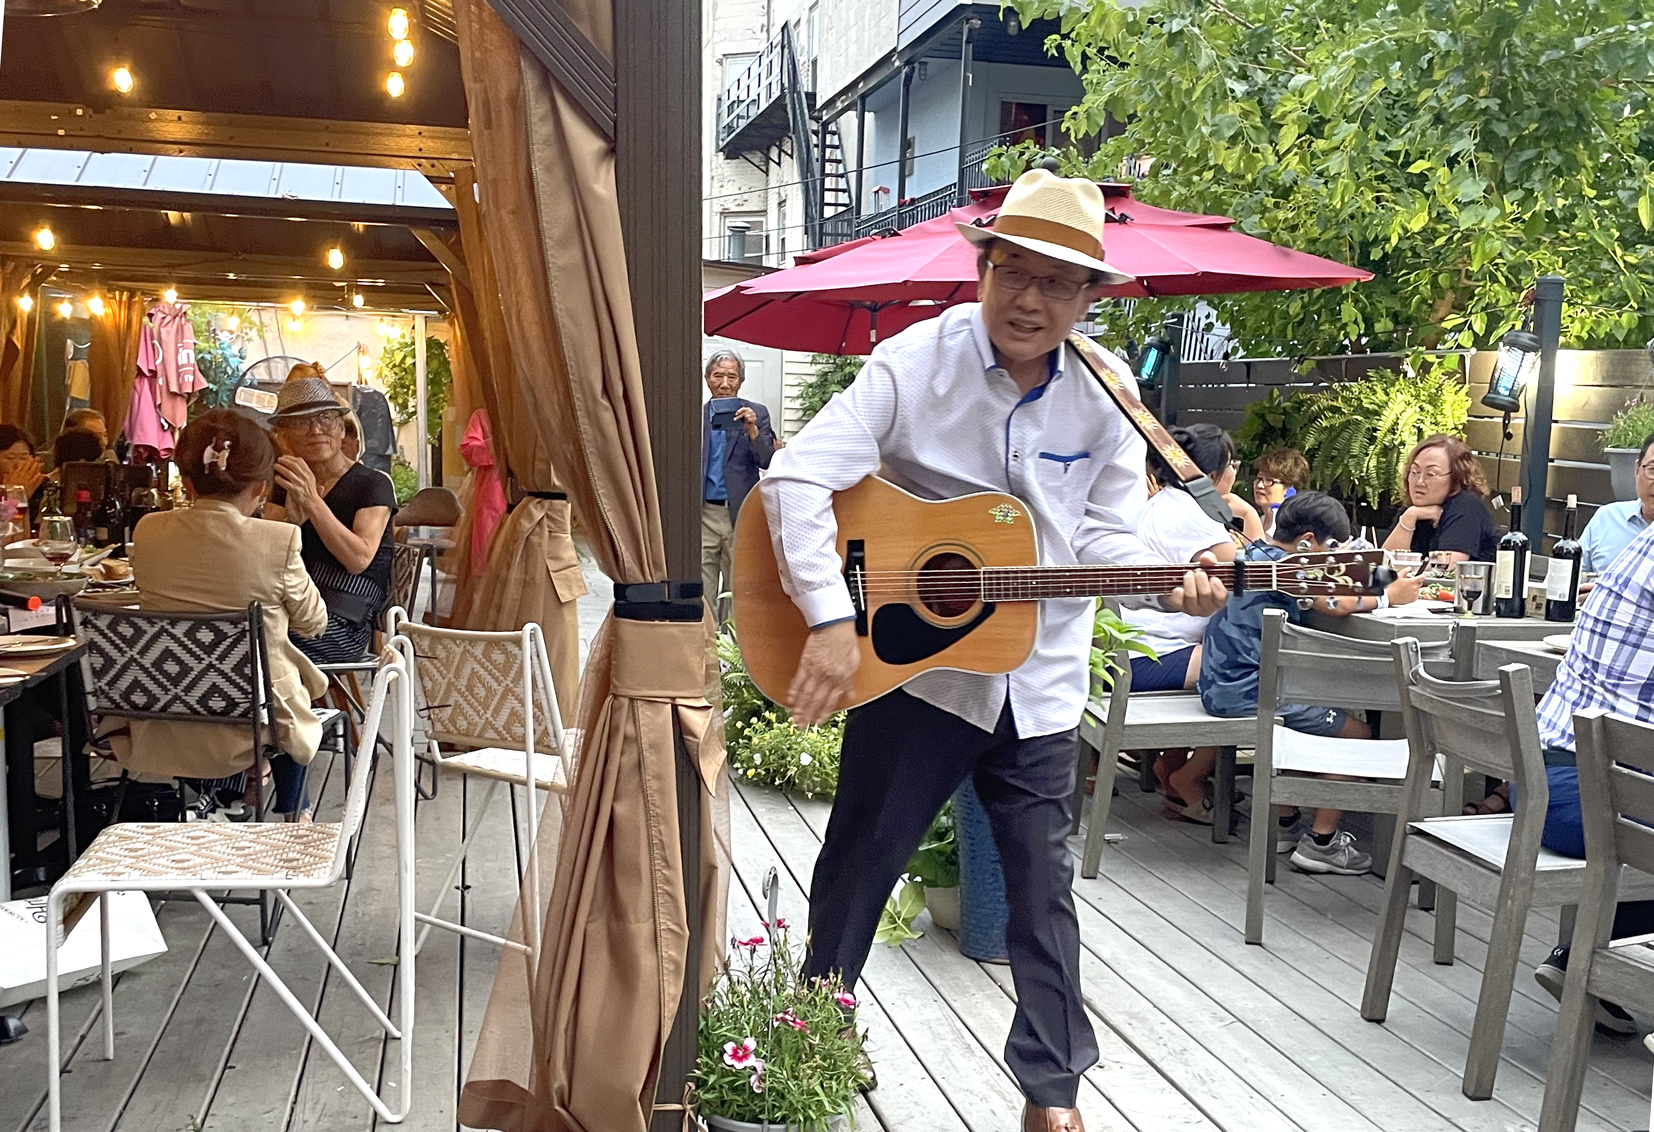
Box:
(1245, 609, 1475, 943)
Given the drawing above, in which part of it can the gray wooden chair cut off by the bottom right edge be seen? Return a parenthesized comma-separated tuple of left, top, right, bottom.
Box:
(1540, 708, 1654, 1132)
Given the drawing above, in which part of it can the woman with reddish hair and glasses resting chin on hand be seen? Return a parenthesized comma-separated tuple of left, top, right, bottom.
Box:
(1384, 434, 1497, 563)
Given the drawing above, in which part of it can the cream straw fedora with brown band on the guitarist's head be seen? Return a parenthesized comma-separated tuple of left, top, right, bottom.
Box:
(959, 169, 1133, 283)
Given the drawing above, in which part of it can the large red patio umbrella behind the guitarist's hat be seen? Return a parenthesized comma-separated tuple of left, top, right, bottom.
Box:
(703, 185, 1373, 354)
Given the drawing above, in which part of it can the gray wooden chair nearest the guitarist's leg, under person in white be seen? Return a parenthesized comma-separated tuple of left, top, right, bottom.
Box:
(1073, 650, 1257, 877)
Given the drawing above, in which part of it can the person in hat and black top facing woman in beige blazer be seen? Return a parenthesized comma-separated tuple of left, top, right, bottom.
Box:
(265, 364, 397, 664)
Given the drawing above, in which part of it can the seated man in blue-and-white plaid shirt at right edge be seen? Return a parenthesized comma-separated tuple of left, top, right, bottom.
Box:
(1533, 526, 1654, 1034)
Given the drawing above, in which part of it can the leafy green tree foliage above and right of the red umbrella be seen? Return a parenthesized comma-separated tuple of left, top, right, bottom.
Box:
(999, 0, 1654, 356)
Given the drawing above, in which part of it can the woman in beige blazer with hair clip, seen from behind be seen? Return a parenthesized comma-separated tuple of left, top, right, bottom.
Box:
(131, 409, 327, 819)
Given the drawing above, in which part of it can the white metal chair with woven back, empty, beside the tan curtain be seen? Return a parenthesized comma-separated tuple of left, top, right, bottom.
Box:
(392, 611, 574, 955)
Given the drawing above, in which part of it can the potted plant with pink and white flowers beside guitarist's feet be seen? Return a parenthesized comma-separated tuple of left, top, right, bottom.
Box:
(695, 917, 868, 1132)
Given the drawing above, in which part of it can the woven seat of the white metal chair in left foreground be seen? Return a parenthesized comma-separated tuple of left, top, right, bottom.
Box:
(60, 821, 341, 889)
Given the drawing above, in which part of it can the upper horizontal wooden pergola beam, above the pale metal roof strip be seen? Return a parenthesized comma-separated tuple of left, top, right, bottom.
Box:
(0, 99, 471, 180)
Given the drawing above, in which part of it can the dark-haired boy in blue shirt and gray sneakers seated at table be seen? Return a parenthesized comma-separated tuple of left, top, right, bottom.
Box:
(1196, 492, 1422, 875)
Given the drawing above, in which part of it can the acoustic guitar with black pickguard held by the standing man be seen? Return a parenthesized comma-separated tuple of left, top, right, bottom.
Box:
(734, 477, 1393, 707)
